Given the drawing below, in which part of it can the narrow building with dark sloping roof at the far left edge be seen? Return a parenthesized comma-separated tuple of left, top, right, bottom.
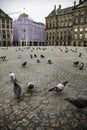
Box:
(0, 9, 13, 46)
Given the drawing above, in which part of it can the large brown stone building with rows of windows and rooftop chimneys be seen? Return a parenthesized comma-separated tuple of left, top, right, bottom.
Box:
(45, 0, 87, 46)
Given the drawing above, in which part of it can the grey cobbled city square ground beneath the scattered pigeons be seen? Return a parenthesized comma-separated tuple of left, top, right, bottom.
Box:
(0, 46, 87, 130)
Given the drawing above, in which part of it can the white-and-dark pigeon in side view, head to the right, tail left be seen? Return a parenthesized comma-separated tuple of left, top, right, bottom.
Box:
(48, 81, 68, 93)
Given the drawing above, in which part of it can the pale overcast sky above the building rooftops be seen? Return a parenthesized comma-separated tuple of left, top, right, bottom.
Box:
(0, 0, 79, 23)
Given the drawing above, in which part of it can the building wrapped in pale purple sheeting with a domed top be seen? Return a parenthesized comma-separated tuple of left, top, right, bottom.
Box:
(13, 13, 45, 46)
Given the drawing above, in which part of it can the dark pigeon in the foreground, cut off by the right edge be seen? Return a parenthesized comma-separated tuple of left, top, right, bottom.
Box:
(64, 98, 87, 109)
